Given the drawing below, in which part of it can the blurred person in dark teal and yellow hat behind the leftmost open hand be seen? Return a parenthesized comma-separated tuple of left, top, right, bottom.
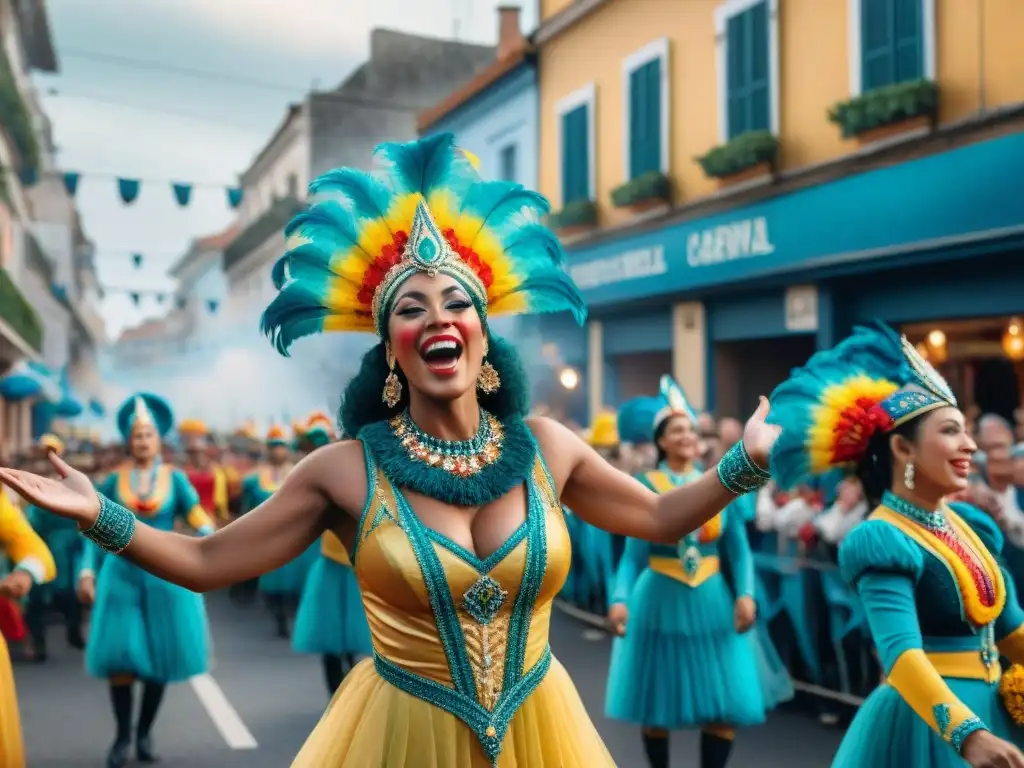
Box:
(25, 434, 85, 663)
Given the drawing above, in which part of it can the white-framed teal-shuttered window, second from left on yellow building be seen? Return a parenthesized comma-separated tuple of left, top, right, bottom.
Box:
(623, 38, 669, 179)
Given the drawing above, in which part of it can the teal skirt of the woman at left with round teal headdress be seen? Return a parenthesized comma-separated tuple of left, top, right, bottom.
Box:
(85, 557, 210, 683)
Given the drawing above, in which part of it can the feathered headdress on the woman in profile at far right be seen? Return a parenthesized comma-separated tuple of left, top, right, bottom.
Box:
(769, 323, 956, 487)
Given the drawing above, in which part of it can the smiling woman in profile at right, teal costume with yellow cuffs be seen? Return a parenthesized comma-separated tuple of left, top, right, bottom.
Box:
(771, 326, 1024, 768)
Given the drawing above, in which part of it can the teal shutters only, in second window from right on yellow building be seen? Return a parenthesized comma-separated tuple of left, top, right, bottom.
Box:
(726, 2, 771, 139)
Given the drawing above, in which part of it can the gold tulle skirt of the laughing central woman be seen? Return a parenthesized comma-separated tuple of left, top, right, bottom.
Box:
(292, 659, 615, 768)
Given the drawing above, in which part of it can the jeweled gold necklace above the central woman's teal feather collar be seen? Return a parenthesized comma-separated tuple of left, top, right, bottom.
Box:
(388, 411, 505, 477)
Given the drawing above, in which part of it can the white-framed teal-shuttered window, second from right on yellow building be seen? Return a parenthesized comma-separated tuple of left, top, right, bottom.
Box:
(715, 0, 778, 143)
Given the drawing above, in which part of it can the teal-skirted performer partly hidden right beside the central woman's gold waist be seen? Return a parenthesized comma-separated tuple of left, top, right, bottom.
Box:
(292, 414, 373, 695)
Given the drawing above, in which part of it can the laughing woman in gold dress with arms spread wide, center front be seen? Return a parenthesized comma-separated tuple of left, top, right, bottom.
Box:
(0, 135, 777, 768)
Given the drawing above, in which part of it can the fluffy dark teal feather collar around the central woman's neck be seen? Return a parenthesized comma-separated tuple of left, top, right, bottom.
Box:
(358, 414, 538, 507)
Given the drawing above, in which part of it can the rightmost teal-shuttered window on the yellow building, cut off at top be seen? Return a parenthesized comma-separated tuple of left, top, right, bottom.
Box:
(850, 0, 934, 93)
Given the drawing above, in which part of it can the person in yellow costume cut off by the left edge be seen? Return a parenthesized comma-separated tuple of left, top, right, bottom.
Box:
(0, 484, 56, 768)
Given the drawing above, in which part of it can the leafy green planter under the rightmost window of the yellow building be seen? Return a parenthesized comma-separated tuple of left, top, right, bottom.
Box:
(828, 80, 939, 144)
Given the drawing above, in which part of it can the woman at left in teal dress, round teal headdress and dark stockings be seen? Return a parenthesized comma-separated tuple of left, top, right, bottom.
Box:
(79, 393, 214, 768)
